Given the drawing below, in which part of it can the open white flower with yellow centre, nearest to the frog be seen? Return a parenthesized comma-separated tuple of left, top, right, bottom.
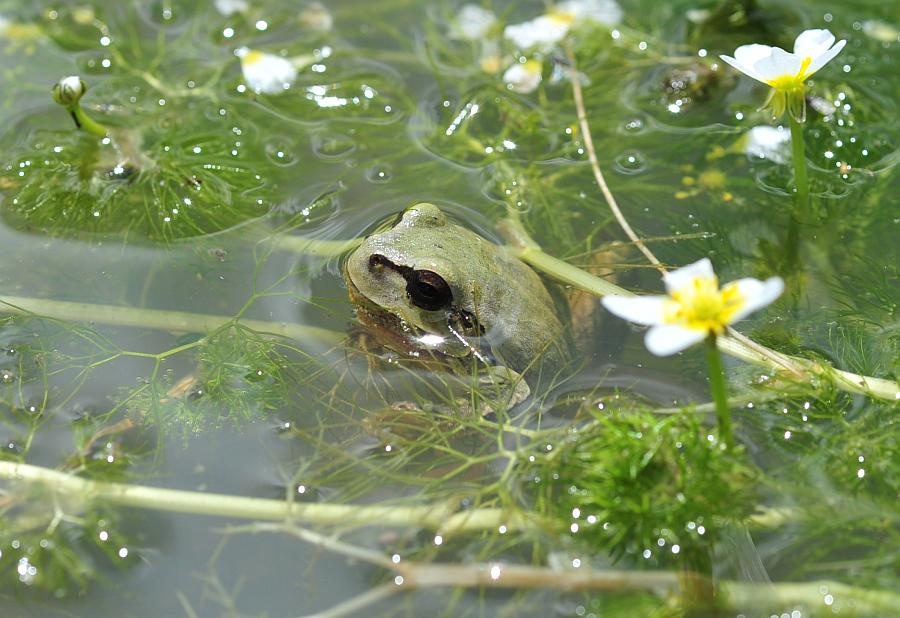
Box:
(602, 258, 784, 356)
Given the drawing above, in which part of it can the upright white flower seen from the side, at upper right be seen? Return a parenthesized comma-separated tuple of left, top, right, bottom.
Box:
(720, 30, 847, 122)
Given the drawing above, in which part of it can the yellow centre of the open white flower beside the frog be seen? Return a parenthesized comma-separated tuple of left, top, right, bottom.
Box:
(663, 276, 745, 335)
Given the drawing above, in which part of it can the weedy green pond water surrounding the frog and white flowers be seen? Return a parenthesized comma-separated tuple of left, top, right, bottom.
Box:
(0, 0, 900, 618)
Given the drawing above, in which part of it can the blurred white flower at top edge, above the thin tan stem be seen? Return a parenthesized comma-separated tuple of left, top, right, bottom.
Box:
(503, 0, 622, 49)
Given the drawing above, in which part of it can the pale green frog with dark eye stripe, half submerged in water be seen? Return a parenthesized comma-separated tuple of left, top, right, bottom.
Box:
(343, 203, 572, 410)
